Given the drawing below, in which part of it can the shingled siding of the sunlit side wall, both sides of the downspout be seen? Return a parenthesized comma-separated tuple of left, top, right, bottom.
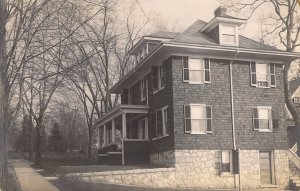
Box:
(172, 56, 287, 150)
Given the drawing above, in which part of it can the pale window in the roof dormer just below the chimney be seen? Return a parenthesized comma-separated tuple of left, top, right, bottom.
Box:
(220, 24, 238, 45)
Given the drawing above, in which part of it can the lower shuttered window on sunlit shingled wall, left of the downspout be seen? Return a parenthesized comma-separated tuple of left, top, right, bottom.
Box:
(184, 104, 212, 134)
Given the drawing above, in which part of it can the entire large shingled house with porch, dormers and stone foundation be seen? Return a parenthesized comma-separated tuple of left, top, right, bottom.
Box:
(96, 7, 300, 190)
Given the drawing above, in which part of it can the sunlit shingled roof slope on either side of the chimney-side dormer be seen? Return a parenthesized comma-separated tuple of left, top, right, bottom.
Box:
(171, 20, 279, 51)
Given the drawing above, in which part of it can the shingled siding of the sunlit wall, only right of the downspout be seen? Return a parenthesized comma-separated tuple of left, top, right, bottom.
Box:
(233, 62, 288, 150)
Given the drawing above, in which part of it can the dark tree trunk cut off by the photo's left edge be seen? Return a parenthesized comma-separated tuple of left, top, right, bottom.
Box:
(0, 0, 9, 190)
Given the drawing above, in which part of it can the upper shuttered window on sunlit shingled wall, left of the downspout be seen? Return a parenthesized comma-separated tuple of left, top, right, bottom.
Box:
(182, 57, 210, 84)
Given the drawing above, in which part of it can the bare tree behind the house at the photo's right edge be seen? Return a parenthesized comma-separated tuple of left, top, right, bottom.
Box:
(220, 0, 300, 128)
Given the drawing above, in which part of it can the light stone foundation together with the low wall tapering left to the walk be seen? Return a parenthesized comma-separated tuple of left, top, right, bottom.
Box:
(64, 150, 289, 191)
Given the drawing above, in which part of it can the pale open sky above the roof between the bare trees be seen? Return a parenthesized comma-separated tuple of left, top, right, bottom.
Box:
(120, 0, 262, 38)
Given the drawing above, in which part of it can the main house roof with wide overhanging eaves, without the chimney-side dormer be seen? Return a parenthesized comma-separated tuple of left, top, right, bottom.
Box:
(110, 20, 300, 93)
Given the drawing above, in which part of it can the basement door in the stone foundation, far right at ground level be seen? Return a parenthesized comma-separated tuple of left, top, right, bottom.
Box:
(259, 152, 272, 185)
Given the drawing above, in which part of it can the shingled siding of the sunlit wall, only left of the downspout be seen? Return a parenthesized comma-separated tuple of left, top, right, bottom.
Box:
(172, 56, 233, 150)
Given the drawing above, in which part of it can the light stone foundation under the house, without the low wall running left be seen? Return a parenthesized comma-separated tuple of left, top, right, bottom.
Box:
(150, 150, 289, 190)
